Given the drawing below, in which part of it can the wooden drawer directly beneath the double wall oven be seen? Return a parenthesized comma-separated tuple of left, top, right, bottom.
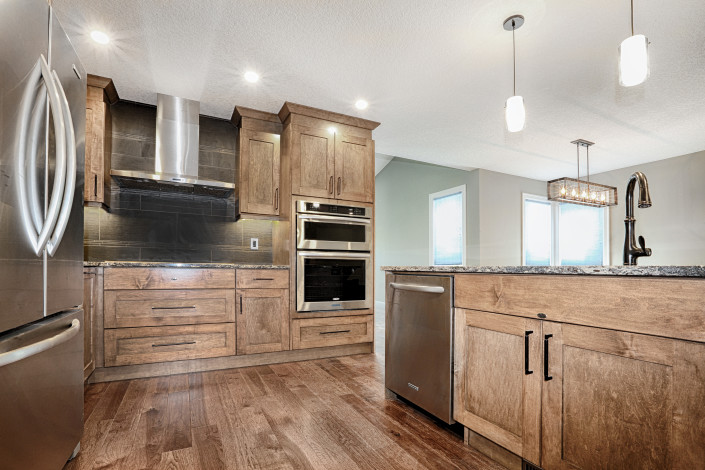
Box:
(291, 315, 374, 349)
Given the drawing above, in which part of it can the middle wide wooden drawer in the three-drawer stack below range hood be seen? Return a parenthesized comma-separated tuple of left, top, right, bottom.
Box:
(104, 289, 235, 328)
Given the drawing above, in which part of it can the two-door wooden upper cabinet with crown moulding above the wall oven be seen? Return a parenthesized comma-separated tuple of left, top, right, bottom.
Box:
(279, 102, 379, 202)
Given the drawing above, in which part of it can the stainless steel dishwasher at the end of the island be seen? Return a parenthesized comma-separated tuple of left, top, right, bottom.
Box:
(384, 273, 454, 424)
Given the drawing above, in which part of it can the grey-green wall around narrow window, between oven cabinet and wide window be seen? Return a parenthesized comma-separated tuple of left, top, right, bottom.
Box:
(375, 158, 546, 302)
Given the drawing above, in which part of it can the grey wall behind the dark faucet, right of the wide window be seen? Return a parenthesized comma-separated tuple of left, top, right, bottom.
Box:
(595, 151, 705, 266)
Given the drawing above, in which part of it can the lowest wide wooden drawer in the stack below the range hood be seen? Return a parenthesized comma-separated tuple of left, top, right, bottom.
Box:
(105, 323, 235, 367)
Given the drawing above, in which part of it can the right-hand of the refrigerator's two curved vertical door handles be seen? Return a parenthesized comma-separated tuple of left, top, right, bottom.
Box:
(47, 71, 77, 256)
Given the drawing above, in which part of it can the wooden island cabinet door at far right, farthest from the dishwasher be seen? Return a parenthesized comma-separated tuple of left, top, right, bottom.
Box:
(542, 322, 705, 470)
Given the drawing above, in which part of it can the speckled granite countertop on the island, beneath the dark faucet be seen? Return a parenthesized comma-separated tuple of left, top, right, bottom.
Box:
(380, 266, 705, 278)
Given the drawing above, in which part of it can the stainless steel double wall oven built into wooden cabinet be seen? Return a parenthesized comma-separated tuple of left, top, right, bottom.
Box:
(296, 201, 374, 312)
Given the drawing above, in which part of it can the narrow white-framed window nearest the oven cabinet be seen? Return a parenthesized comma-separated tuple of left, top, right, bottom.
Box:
(428, 185, 465, 266)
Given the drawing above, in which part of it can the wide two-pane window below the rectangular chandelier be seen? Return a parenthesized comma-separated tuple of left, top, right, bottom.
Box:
(522, 194, 609, 266)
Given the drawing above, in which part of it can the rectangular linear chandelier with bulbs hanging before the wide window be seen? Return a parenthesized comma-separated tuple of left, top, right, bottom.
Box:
(547, 139, 617, 207)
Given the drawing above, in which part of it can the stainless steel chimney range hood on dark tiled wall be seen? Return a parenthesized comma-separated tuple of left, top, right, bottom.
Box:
(110, 94, 235, 197)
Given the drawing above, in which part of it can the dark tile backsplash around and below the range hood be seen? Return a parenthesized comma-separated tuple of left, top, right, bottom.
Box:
(84, 101, 274, 264)
